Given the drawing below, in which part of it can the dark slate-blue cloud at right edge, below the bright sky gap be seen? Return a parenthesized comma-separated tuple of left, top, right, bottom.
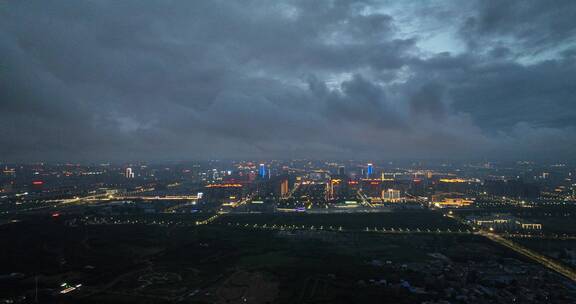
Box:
(453, 60, 576, 130)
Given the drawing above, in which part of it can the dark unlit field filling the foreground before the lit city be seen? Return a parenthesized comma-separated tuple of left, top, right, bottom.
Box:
(0, 213, 568, 303)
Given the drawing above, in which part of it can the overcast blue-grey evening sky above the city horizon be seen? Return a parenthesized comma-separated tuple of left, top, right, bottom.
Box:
(0, 0, 576, 161)
